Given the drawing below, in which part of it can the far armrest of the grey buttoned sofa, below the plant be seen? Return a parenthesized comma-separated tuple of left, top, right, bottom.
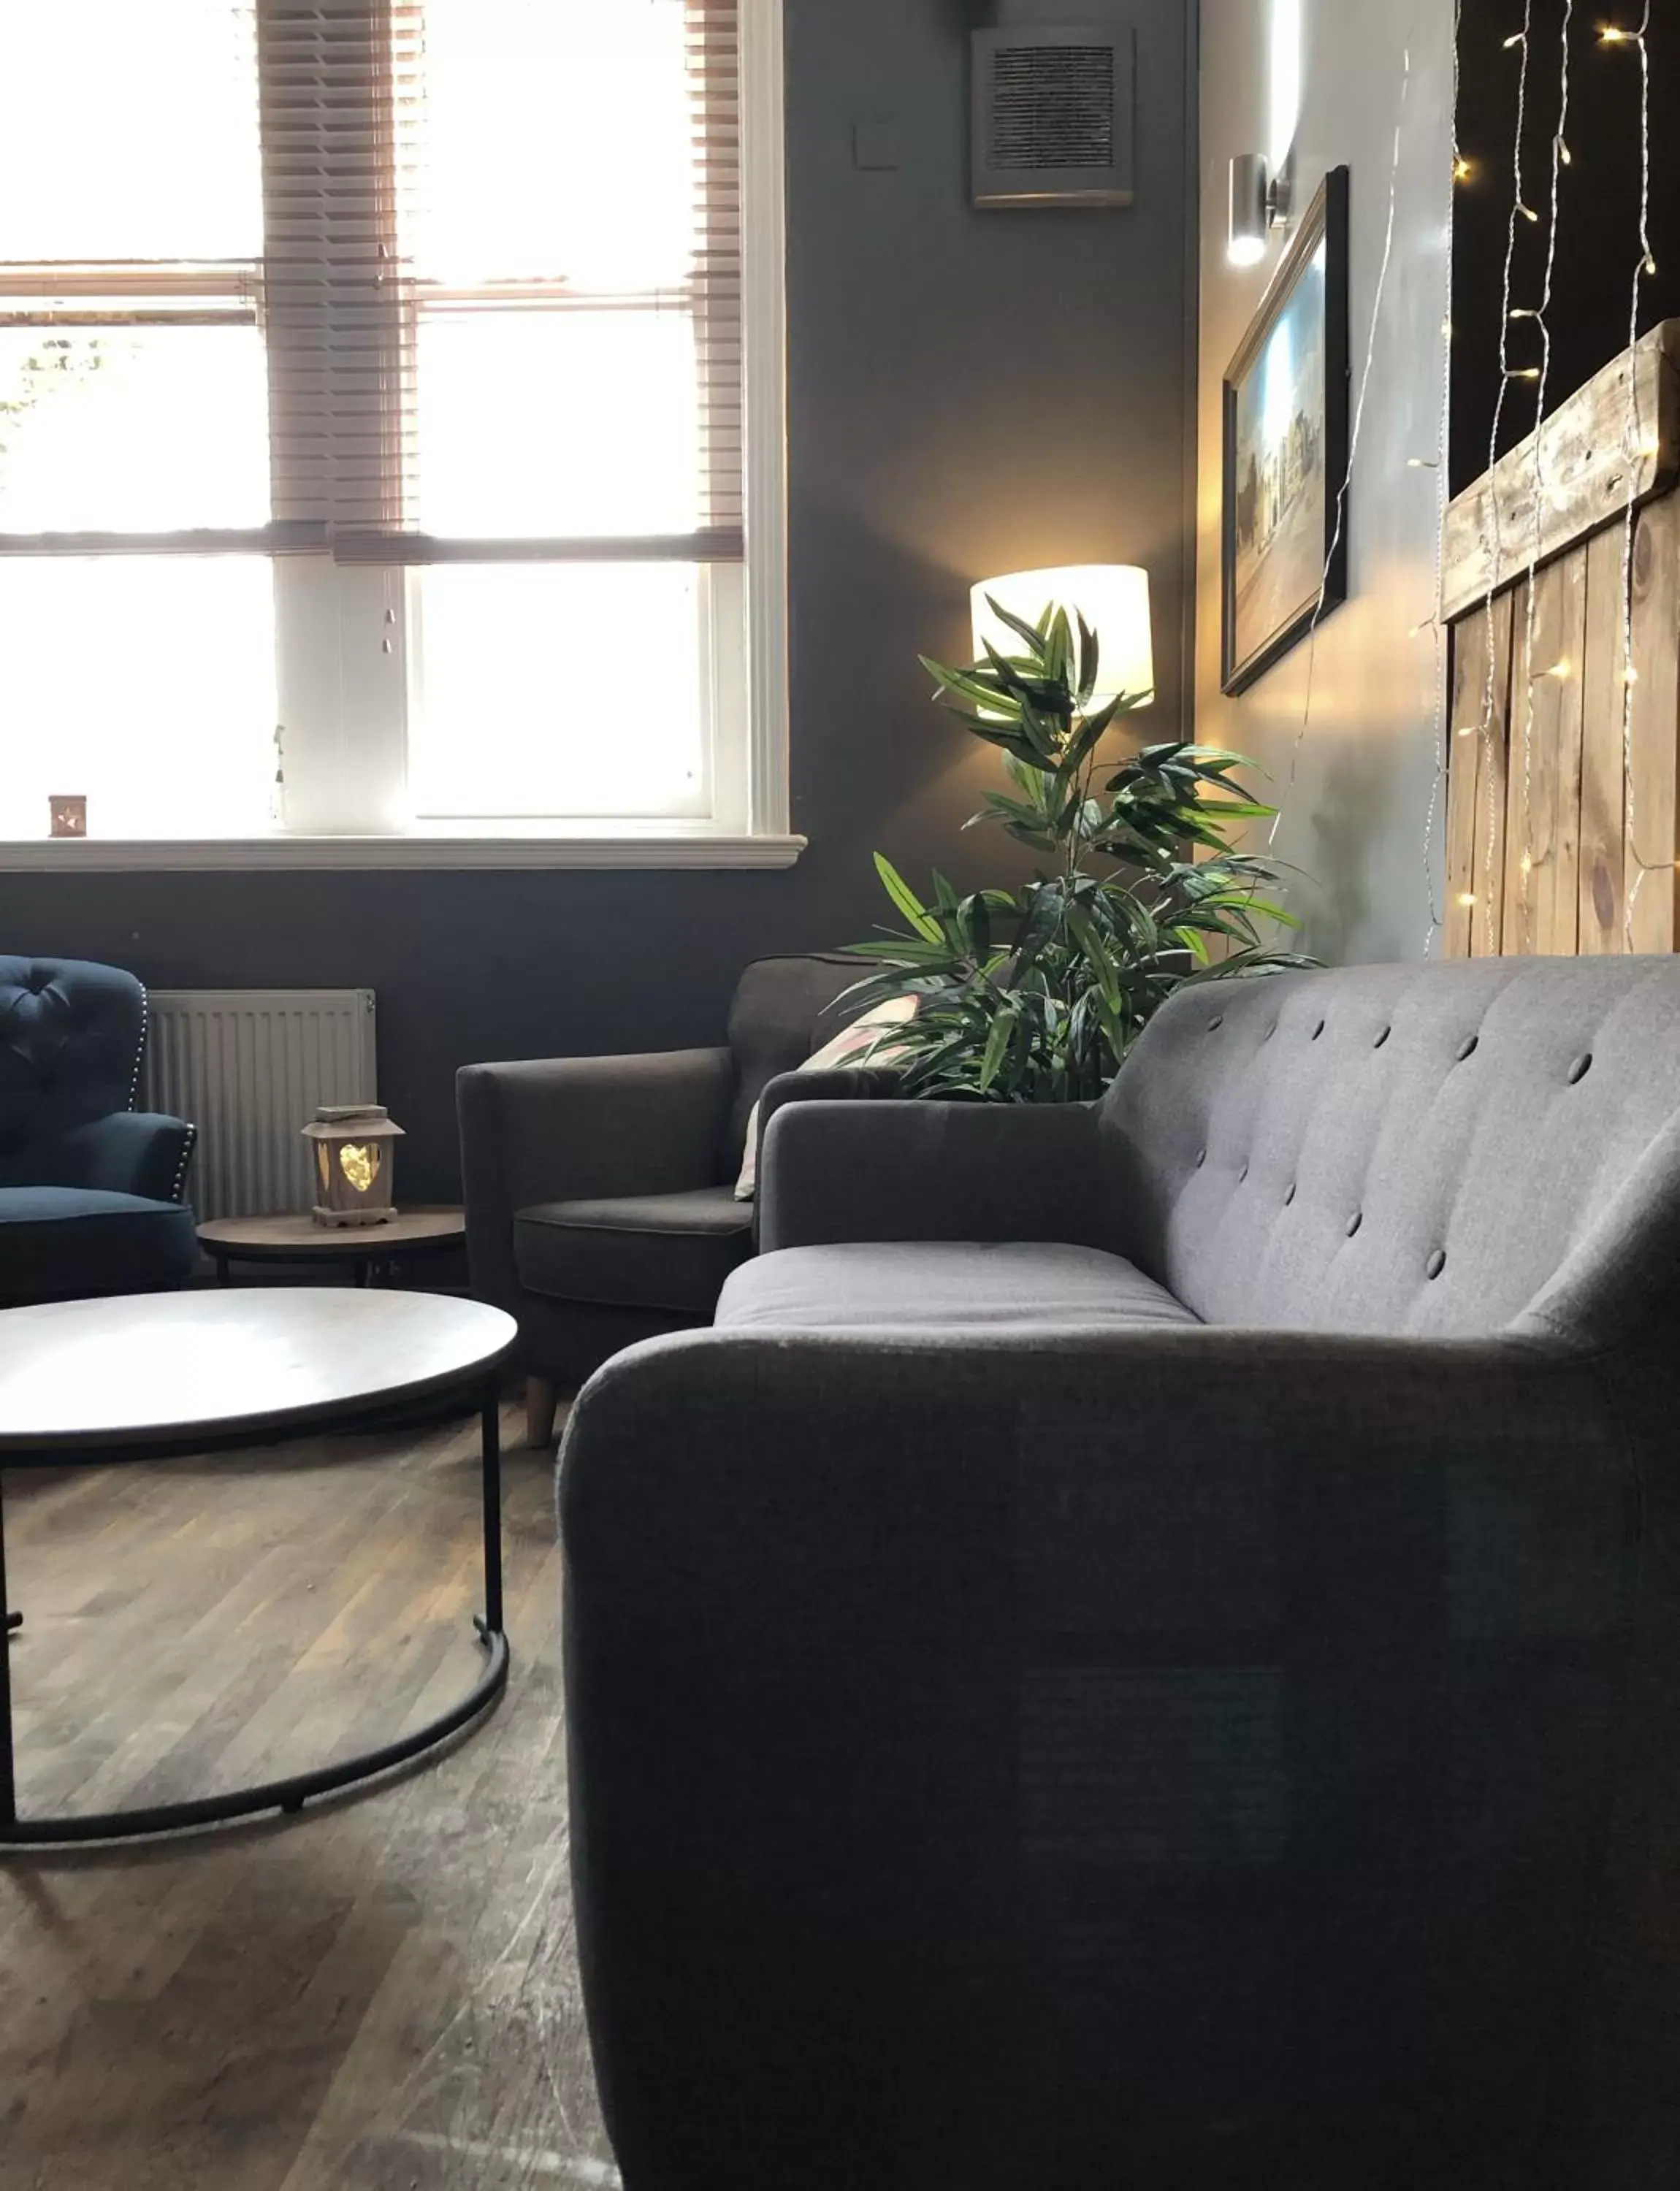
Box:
(758, 1102, 1108, 1251)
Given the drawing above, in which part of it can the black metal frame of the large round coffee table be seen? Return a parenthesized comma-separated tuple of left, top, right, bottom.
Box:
(0, 1374, 511, 1854)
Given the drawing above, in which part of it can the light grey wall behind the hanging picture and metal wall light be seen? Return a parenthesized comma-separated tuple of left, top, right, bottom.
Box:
(1196, 0, 1454, 962)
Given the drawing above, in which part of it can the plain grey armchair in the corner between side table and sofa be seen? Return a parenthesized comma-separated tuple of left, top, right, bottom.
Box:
(458, 957, 880, 1446)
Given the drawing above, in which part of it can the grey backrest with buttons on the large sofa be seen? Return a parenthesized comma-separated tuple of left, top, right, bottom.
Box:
(1101, 957, 1680, 1337)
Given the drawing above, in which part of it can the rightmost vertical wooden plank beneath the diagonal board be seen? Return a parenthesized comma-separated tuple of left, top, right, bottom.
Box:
(1625, 495, 1680, 951)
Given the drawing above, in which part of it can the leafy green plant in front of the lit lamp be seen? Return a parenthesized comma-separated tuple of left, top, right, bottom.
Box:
(852, 600, 1314, 1102)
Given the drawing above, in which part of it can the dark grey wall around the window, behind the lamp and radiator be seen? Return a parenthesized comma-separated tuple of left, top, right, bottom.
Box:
(0, 0, 1191, 1198)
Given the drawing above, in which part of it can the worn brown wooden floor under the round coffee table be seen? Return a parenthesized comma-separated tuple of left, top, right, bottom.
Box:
(0, 1413, 618, 2191)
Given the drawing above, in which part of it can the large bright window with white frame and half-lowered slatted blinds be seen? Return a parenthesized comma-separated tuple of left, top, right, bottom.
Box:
(0, 0, 798, 865)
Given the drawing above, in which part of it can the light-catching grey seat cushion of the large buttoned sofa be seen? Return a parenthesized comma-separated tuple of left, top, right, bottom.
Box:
(719, 1240, 1198, 1337)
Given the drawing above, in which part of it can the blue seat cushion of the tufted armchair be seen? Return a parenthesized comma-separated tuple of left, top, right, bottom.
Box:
(0, 1188, 199, 1304)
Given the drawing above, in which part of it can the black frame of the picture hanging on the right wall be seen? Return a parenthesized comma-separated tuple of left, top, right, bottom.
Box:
(1220, 167, 1351, 695)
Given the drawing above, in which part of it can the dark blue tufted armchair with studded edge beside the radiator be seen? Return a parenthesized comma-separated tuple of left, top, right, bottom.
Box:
(0, 957, 197, 1304)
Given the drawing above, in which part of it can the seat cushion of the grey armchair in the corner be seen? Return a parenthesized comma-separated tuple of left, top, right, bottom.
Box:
(513, 1185, 754, 1317)
